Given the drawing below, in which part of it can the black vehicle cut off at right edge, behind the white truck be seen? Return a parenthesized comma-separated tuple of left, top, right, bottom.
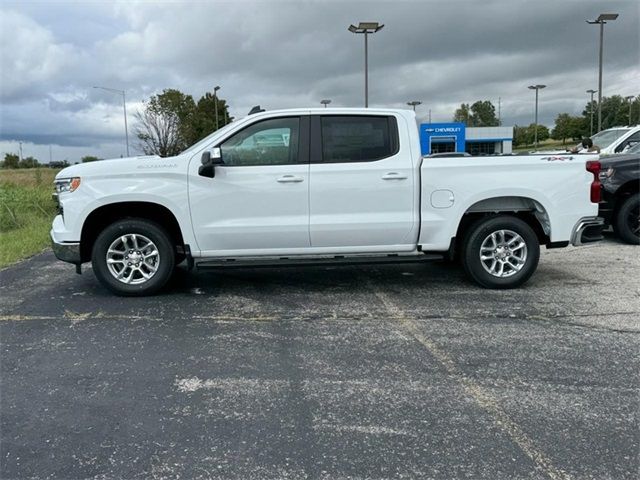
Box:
(598, 143, 640, 245)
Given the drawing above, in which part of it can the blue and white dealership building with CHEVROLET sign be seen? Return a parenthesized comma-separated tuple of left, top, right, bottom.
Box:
(420, 123, 513, 156)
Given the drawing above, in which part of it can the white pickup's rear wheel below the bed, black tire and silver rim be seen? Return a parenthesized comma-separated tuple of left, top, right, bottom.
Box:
(461, 215, 540, 289)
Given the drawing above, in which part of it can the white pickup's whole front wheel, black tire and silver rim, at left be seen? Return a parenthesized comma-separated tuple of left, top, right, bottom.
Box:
(91, 218, 175, 296)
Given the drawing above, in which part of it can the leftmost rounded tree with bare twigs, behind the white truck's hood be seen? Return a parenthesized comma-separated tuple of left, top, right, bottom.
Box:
(134, 89, 198, 157)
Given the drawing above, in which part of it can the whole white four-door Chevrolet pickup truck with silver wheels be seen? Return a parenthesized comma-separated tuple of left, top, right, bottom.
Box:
(51, 108, 603, 295)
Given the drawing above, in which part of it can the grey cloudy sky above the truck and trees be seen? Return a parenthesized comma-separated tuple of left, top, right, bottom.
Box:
(0, 0, 640, 162)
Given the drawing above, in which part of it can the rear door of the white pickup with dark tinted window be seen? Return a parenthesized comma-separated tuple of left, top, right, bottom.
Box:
(309, 115, 416, 252)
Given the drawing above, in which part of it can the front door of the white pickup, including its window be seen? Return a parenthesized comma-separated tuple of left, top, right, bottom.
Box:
(189, 116, 310, 256)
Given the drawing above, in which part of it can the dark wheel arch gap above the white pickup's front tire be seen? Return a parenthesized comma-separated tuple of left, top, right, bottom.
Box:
(80, 201, 185, 262)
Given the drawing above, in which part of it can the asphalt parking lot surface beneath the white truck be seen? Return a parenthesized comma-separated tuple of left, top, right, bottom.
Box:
(0, 238, 640, 480)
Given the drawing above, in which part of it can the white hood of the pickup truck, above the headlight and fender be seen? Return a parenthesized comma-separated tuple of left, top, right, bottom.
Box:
(56, 155, 182, 178)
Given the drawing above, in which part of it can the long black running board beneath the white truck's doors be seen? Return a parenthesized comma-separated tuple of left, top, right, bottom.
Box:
(194, 254, 443, 270)
